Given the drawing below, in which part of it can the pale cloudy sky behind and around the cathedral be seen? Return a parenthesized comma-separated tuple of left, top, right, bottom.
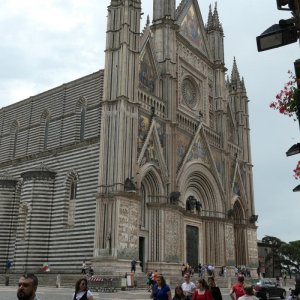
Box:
(0, 0, 300, 242)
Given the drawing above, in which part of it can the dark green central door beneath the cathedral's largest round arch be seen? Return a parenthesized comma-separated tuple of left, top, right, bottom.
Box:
(186, 225, 199, 269)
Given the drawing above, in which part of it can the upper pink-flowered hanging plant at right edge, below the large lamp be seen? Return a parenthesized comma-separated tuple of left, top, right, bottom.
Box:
(270, 70, 298, 120)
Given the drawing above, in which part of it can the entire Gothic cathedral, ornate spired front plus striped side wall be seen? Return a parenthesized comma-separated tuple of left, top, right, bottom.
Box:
(0, 0, 257, 273)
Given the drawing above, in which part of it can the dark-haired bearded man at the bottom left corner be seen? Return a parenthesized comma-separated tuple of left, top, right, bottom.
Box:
(17, 273, 38, 300)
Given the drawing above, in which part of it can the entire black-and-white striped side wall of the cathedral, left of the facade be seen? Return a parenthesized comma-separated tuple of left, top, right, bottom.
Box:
(0, 71, 103, 273)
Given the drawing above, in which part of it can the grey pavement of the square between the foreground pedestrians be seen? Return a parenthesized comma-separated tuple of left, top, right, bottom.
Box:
(0, 286, 229, 300)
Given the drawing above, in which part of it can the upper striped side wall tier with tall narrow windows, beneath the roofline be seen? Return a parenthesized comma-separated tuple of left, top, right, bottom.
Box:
(0, 71, 103, 163)
